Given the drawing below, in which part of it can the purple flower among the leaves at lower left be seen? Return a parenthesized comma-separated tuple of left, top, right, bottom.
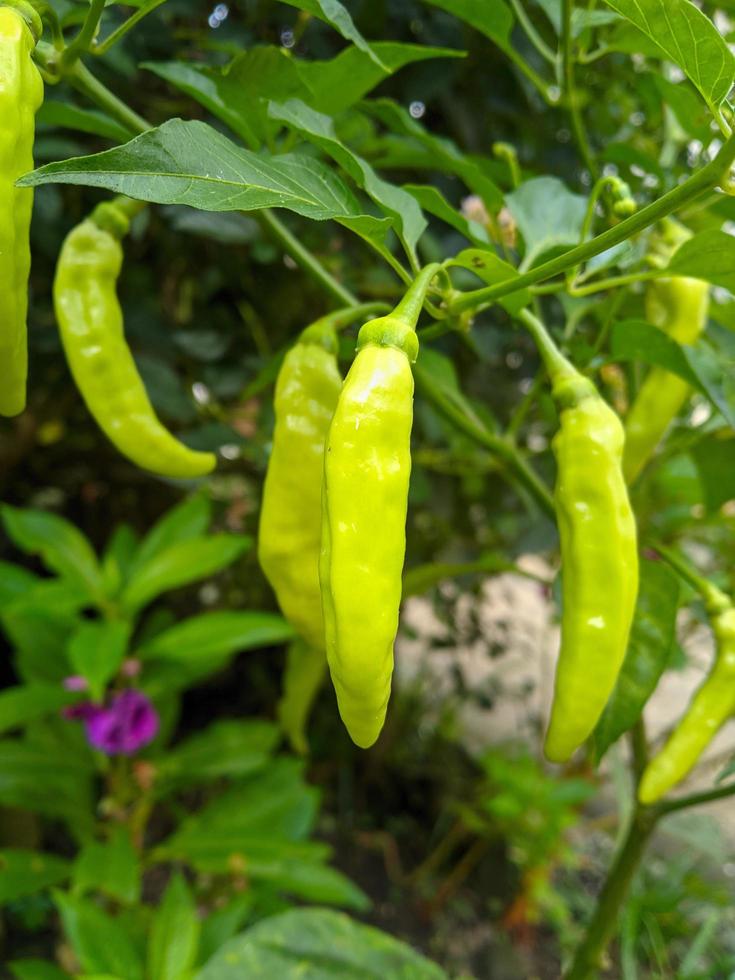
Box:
(66, 688, 158, 755)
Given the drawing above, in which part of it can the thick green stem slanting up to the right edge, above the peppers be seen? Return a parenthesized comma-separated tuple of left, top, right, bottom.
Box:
(448, 135, 735, 316)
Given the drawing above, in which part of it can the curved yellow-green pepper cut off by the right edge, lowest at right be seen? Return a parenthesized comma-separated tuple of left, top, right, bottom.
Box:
(638, 593, 735, 804)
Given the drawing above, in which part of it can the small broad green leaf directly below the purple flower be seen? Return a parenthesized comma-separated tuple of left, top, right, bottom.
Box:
(72, 826, 141, 905)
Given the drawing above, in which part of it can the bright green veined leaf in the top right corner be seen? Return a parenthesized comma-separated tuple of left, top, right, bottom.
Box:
(607, 0, 735, 108)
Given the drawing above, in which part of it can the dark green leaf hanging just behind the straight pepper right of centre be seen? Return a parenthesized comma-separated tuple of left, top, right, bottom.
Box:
(594, 561, 679, 762)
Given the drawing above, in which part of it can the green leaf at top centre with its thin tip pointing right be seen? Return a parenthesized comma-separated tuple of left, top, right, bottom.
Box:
(296, 41, 465, 116)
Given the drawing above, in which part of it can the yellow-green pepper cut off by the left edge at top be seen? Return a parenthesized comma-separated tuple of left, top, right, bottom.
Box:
(0, 7, 43, 415)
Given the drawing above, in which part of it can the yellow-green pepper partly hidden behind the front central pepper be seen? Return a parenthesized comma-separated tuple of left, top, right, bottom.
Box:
(258, 303, 385, 655)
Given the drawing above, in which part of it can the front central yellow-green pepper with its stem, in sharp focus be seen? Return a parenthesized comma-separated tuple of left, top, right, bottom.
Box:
(319, 266, 438, 748)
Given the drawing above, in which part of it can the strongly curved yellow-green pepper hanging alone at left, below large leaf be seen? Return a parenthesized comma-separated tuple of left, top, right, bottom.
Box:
(54, 204, 216, 478)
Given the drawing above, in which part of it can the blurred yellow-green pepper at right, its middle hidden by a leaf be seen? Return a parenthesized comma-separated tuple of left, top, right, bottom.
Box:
(623, 276, 709, 483)
